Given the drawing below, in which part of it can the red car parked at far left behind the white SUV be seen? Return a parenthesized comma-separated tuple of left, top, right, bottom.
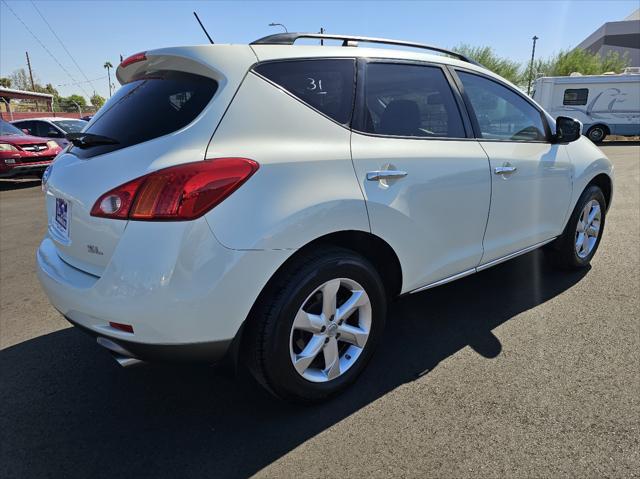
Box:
(0, 120, 62, 178)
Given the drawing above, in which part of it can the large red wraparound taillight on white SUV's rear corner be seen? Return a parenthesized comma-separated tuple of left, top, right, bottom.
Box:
(91, 158, 259, 221)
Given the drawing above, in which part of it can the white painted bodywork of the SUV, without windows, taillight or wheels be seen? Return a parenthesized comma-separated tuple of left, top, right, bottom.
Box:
(37, 40, 612, 360)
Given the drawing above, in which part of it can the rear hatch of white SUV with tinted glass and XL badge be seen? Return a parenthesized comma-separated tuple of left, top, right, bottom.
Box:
(45, 45, 255, 276)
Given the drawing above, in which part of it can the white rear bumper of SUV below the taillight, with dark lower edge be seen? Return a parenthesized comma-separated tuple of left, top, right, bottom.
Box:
(37, 218, 291, 361)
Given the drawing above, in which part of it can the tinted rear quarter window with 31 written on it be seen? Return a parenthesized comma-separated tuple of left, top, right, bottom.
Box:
(255, 58, 355, 125)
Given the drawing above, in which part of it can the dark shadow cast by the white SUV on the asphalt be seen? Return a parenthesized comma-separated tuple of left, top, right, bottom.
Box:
(0, 251, 587, 477)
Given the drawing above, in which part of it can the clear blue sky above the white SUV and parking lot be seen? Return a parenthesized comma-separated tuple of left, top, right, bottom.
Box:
(0, 0, 638, 96)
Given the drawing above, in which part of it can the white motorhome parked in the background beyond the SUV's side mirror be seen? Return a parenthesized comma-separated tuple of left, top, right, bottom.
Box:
(532, 68, 640, 143)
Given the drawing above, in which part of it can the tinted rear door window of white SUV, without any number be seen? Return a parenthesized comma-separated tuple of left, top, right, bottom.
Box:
(362, 63, 465, 138)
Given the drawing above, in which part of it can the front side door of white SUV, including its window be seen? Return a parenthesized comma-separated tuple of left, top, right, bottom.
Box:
(457, 69, 572, 265)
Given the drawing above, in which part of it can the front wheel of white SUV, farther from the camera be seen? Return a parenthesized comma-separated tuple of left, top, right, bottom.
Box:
(546, 185, 607, 269)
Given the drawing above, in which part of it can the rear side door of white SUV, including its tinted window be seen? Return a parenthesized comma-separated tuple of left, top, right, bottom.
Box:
(351, 60, 491, 292)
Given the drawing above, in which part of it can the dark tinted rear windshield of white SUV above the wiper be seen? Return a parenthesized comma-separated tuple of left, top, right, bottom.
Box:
(69, 70, 218, 158)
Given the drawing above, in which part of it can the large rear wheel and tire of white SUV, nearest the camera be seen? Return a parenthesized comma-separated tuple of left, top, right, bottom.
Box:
(243, 247, 387, 402)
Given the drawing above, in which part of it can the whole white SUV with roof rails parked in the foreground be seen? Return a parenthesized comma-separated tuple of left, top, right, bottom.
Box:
(37, 34, 612, 401)
